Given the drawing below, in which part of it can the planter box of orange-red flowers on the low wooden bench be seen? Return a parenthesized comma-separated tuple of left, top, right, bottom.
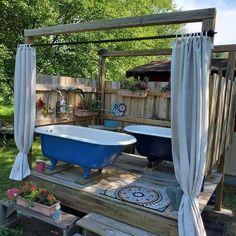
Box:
(16, 182, 59, 216)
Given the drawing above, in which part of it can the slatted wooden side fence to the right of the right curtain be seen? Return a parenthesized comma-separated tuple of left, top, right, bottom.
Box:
(206, 72, 236, 175)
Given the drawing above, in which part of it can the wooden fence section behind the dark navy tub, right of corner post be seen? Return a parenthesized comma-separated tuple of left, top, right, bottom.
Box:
(104, 81, 170, 127)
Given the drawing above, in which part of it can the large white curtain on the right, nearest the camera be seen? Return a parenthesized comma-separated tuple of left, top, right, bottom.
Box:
(171, 35, 212, 236)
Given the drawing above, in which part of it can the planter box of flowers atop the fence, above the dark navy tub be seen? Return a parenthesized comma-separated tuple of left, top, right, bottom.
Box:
(118, 77, 149, 97)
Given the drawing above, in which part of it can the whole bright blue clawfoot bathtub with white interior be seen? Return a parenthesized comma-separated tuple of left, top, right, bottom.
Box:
(35, 125, 136, 179)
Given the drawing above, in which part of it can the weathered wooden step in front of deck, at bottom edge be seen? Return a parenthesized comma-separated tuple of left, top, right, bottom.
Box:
(76, 212, 156, 236)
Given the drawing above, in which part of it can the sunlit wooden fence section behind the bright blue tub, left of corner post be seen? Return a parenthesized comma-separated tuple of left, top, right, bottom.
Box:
(36, 74, 97, 126)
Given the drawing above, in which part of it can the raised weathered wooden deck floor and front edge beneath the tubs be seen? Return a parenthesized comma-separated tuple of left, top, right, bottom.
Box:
(30, 154, 221, 235)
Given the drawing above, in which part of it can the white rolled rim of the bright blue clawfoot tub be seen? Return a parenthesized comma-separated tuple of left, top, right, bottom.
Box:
(34, 125, 137, 146)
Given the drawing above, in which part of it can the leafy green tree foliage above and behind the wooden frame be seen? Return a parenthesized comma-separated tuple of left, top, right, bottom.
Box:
(0, 0, 181, 100)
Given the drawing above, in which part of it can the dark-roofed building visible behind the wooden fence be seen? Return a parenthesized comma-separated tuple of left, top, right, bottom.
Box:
(126, 59, 236, 176)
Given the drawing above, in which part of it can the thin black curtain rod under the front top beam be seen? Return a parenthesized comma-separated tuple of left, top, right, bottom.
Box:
(27, 30, 217, 47)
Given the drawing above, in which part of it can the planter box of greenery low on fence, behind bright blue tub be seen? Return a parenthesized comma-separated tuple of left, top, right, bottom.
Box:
(74, 99, 102, 116)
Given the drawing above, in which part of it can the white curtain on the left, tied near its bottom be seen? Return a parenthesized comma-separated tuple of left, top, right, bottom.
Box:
(9, 45, 36, 180)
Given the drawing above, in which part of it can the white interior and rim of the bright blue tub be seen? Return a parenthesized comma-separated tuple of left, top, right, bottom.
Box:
(35, 125, 136, 145)
